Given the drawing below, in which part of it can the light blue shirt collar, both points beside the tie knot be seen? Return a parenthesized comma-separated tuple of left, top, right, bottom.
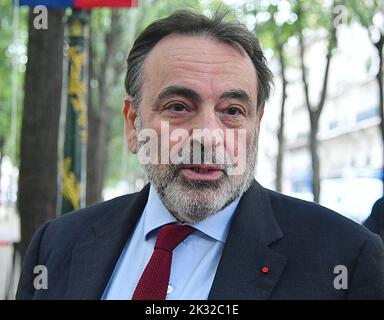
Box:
(144, 185, 240, 243)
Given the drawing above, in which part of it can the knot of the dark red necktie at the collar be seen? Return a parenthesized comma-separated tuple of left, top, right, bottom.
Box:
(155, 224, 194, 252)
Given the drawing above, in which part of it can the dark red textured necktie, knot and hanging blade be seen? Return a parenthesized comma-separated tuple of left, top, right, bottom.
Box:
(132, 224, 194, 300)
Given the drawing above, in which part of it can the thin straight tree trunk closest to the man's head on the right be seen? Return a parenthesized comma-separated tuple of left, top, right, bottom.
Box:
(276, 45, 287, 192)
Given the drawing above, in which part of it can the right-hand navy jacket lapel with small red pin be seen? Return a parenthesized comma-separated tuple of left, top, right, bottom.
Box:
(208, 181, 287, 300)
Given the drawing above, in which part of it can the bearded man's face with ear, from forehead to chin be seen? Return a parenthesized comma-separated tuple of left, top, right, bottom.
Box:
(124, 34, 262, 222)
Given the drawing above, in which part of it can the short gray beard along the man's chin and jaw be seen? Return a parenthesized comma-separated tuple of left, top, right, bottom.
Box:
(138, 117, 258, 223)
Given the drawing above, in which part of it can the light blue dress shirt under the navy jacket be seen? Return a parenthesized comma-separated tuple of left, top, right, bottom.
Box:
(102, 186, 240, 300)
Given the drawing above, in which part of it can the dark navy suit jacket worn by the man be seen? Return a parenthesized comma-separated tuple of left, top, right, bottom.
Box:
(17, 181, 384, 299)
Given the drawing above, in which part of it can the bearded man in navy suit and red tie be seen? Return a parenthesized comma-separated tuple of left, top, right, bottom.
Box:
(17, 12, 384, 299)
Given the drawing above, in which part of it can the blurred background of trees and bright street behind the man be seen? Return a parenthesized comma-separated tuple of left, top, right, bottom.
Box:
(0, 0, 384, 299)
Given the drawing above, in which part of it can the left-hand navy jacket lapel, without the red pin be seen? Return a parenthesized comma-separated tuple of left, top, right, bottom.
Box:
(66, 185, 149, 300)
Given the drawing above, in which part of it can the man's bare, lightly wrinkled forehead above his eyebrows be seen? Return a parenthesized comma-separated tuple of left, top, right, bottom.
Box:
(143, 34, 257, 102)
